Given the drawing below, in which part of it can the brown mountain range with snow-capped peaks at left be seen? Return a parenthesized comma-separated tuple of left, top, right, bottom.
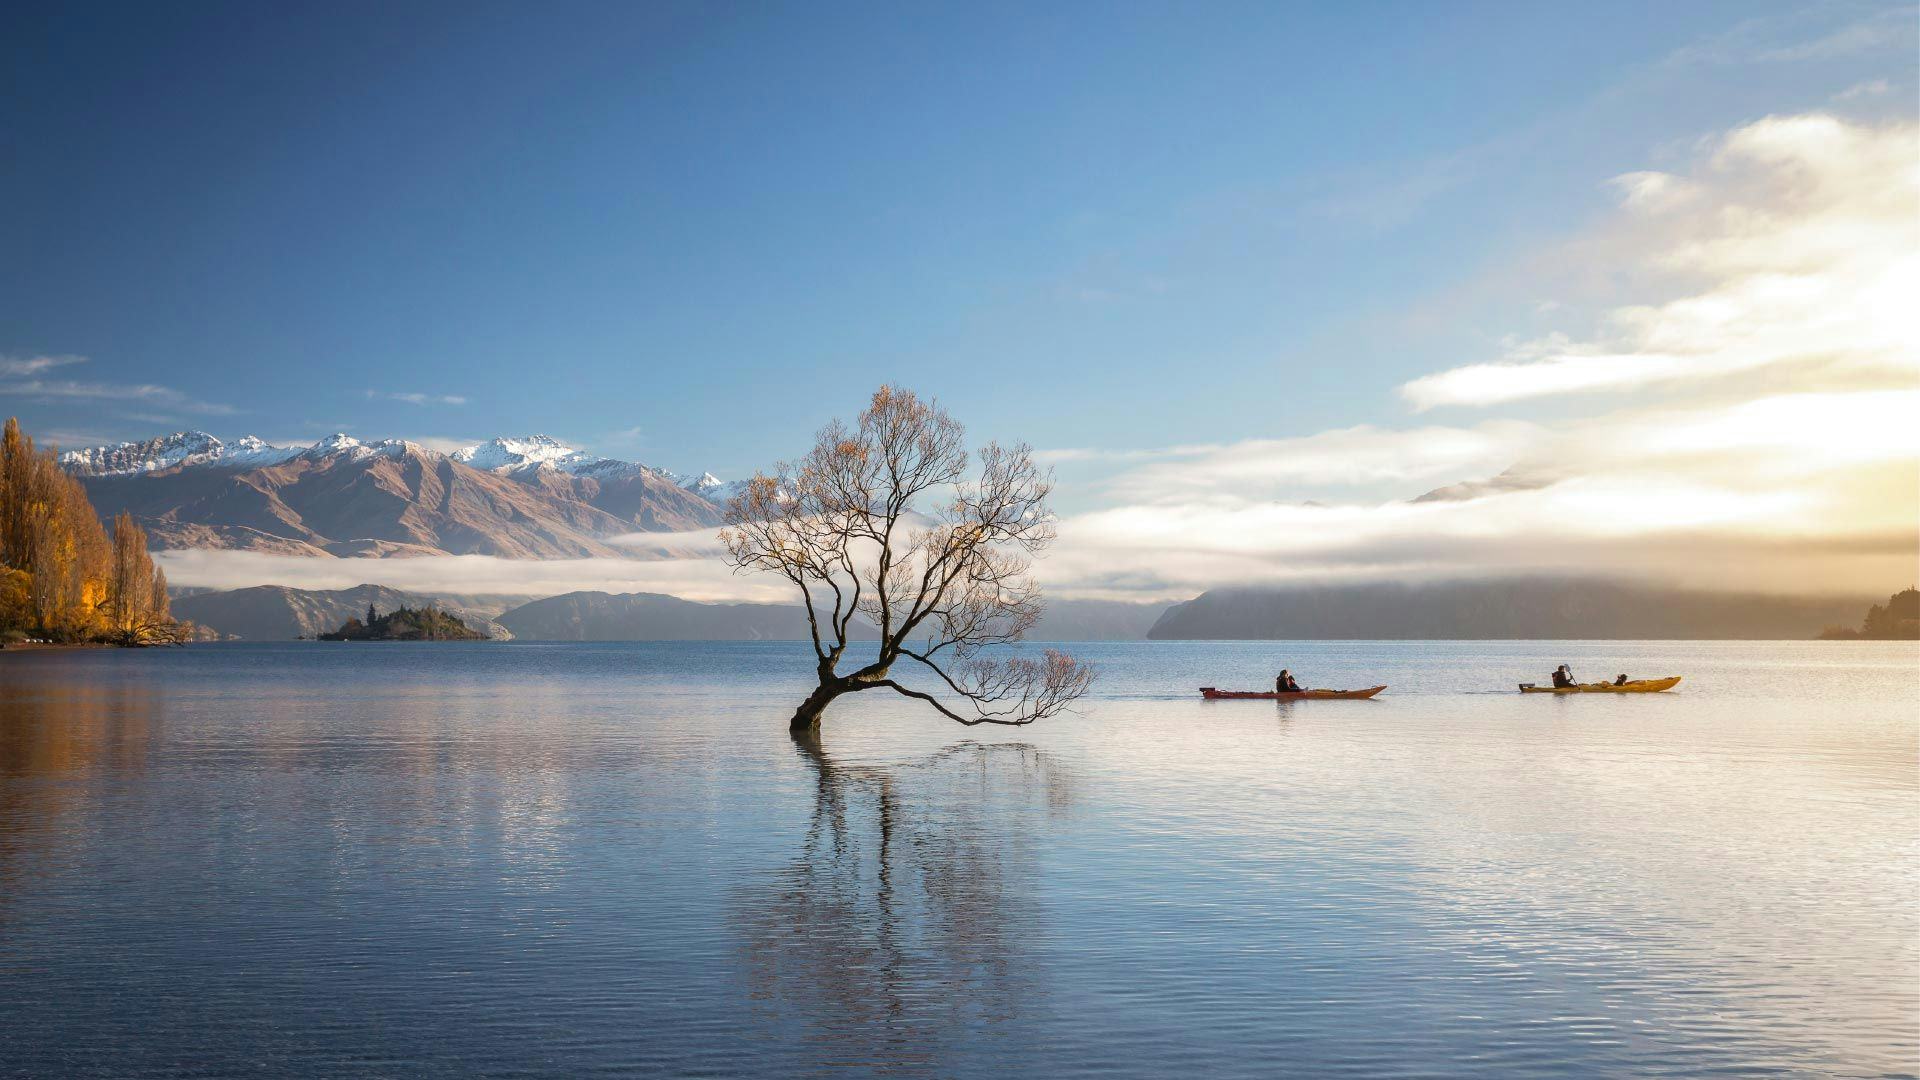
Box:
(61, 430, 726, 559)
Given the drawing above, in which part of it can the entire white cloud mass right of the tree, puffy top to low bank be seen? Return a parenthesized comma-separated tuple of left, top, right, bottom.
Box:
(1041, 113, 1920, 598)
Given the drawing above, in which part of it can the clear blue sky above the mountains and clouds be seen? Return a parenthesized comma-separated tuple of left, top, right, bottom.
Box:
(0, 2, 1916, 534)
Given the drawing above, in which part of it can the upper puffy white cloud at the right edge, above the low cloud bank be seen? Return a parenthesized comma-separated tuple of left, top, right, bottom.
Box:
(1400, 113, 1920, 409)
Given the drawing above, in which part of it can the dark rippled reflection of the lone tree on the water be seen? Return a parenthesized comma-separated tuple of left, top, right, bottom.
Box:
(739, 730, 1071, 1067)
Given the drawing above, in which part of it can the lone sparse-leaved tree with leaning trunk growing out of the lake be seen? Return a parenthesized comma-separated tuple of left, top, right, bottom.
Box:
(722, 386, 1092, 730)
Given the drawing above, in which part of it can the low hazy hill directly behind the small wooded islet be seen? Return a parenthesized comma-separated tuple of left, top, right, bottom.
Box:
(173, 584, 509, 642)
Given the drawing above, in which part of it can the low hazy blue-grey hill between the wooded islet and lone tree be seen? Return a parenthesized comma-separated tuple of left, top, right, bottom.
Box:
(499, 592, 874, 642)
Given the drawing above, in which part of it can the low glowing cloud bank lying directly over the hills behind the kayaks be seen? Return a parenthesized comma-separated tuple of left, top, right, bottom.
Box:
(1041, 390, 1920, 598)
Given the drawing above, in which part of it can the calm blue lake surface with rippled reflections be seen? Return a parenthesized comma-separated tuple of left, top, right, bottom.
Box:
(0, 642, 1920, 1076)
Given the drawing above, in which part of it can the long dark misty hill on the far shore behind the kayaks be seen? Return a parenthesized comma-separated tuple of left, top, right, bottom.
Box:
(1148, 578, 1864, 640)
